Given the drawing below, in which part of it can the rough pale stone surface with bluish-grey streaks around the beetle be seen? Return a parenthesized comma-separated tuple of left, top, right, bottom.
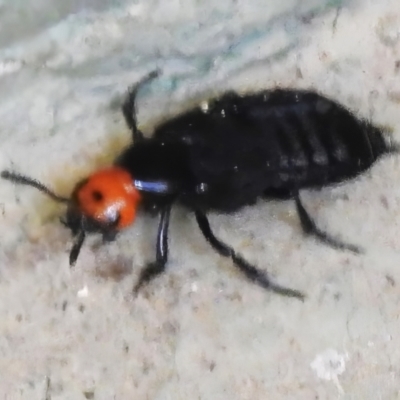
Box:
(0, 0, 400, 400)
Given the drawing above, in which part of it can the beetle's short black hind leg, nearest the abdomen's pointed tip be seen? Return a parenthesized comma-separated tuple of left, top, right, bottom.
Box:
(294, 192, 362, 254)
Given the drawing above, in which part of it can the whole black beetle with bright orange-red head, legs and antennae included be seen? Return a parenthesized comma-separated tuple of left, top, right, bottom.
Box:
(1, 71, 397, 299)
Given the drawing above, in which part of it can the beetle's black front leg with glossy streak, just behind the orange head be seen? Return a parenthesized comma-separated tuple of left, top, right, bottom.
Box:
(133, 204, 172, 293)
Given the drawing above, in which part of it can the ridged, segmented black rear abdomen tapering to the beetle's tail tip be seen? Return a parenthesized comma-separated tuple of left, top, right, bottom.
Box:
(246, 90, 388, 189)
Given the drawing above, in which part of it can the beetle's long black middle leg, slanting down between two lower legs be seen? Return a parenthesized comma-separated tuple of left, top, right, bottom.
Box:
(195, 211, 305, 300)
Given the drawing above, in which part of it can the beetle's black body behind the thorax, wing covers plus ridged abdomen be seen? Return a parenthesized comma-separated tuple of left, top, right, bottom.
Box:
(154, 89, 394, 210)
